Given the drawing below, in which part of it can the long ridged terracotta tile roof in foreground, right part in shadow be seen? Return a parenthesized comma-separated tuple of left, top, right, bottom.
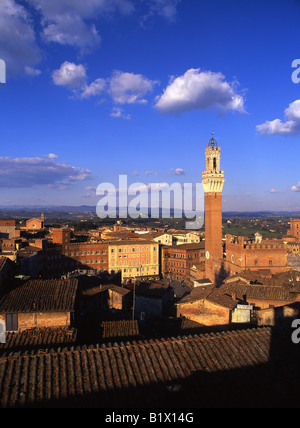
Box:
(0, 328, 300, 408)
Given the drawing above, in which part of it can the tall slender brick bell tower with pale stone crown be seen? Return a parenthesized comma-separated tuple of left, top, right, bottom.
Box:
(202, 132, 225, 283)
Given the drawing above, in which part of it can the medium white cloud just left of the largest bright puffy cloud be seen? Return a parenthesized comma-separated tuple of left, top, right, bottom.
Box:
(109, 71, 157, 104)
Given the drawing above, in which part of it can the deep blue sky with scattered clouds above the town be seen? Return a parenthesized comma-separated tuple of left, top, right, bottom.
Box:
(0, 0, 300, 211)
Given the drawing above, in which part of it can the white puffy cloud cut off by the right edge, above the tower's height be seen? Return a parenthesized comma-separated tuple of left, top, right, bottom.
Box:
(256, 100, 300, 136)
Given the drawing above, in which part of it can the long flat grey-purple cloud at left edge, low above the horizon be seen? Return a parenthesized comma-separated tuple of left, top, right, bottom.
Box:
(0, 157, 90, 188)
